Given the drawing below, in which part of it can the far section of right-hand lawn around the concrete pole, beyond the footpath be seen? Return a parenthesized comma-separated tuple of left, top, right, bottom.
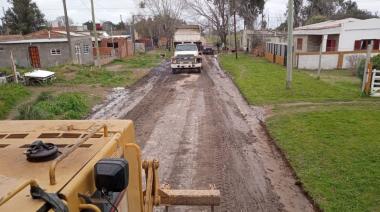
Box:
(220, 54, 360, 105)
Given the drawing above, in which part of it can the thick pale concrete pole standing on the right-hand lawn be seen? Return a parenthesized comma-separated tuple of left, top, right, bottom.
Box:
(286, 0, 294, 89)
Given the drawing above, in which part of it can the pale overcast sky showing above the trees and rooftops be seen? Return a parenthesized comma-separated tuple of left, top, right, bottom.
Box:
(0, 0, 380, 27)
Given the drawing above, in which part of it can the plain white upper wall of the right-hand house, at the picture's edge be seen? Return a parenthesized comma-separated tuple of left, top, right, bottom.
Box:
(338, 18, 380, 51)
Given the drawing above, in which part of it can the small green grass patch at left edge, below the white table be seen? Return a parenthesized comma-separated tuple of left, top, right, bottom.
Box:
(0, 84, 30, 119)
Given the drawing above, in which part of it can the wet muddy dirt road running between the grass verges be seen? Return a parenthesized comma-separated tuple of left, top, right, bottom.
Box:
(90, 57, 313, 211)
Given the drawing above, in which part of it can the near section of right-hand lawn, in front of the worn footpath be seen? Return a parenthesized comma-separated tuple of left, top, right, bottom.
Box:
(268, 106, 380, 211)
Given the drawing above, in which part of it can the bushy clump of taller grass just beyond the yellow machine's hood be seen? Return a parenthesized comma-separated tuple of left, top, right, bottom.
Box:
(18, 92, 90, 120)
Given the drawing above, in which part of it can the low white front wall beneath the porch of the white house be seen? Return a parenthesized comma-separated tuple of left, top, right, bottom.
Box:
(298, 54, 339, 70)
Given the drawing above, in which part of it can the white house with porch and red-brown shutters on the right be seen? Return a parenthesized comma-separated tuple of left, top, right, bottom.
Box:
(294, 18, 380, 69)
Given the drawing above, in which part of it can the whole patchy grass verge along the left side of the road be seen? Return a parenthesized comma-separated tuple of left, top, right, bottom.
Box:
(0, 51, 163, 120)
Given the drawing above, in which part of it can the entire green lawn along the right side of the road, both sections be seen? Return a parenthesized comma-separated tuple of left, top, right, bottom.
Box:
(220, 55, 380, 211)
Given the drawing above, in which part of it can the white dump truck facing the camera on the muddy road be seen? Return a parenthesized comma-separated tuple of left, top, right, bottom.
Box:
(170, 25, 202, 74)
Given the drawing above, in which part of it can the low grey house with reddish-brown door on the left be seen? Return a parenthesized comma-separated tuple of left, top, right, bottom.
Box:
(0, 30, 94, 68)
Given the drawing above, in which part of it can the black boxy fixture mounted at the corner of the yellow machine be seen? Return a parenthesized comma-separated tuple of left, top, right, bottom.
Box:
(94, 158, 129, 192)
